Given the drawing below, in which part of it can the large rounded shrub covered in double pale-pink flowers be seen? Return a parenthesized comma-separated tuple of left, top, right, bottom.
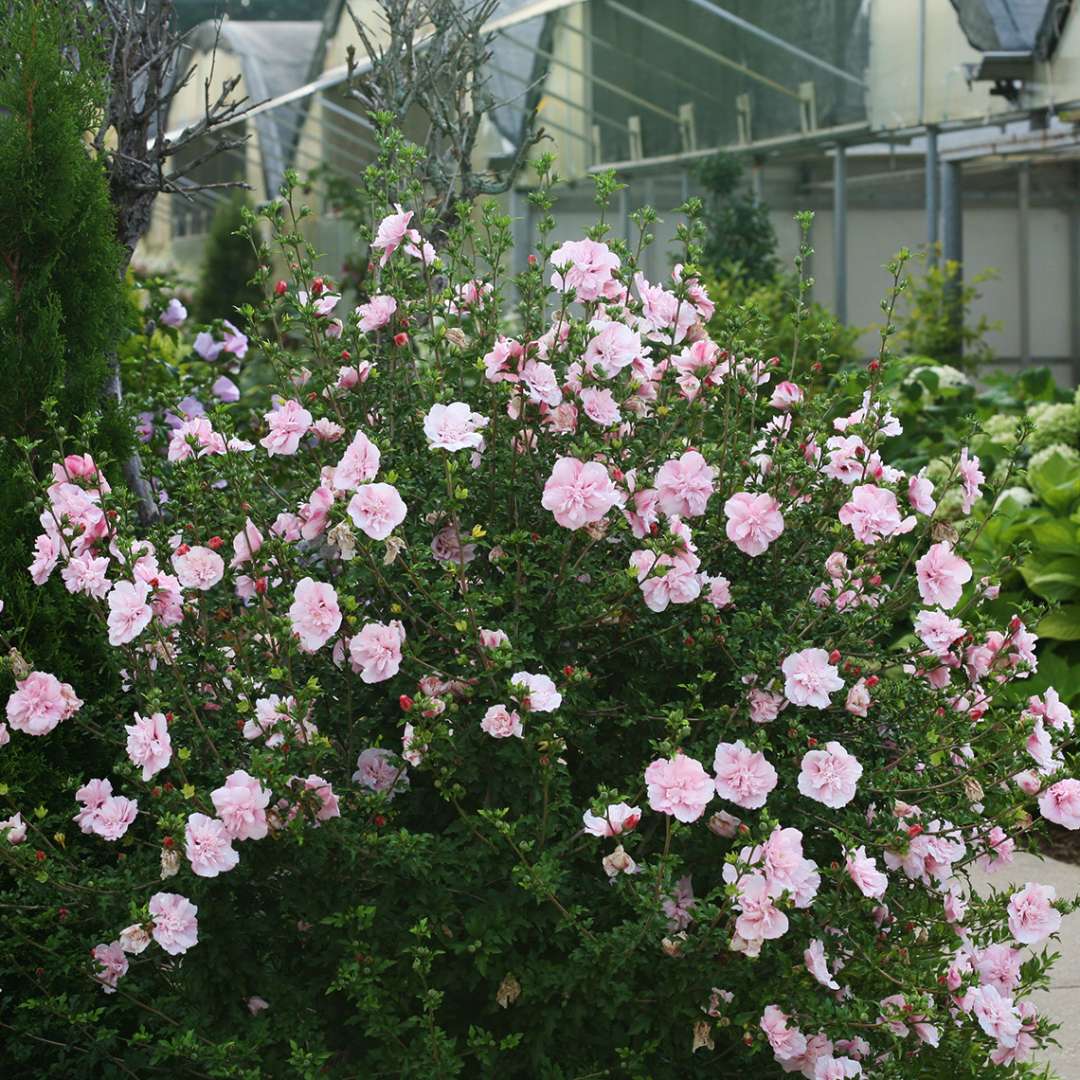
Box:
(0, 135, 1080, 1080)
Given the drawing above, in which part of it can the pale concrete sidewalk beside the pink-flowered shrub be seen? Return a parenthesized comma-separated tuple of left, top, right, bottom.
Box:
(972, 854, 1080, 1080)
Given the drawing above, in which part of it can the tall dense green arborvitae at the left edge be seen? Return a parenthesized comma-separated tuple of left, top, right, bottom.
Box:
(0, 0, 131, 670)
